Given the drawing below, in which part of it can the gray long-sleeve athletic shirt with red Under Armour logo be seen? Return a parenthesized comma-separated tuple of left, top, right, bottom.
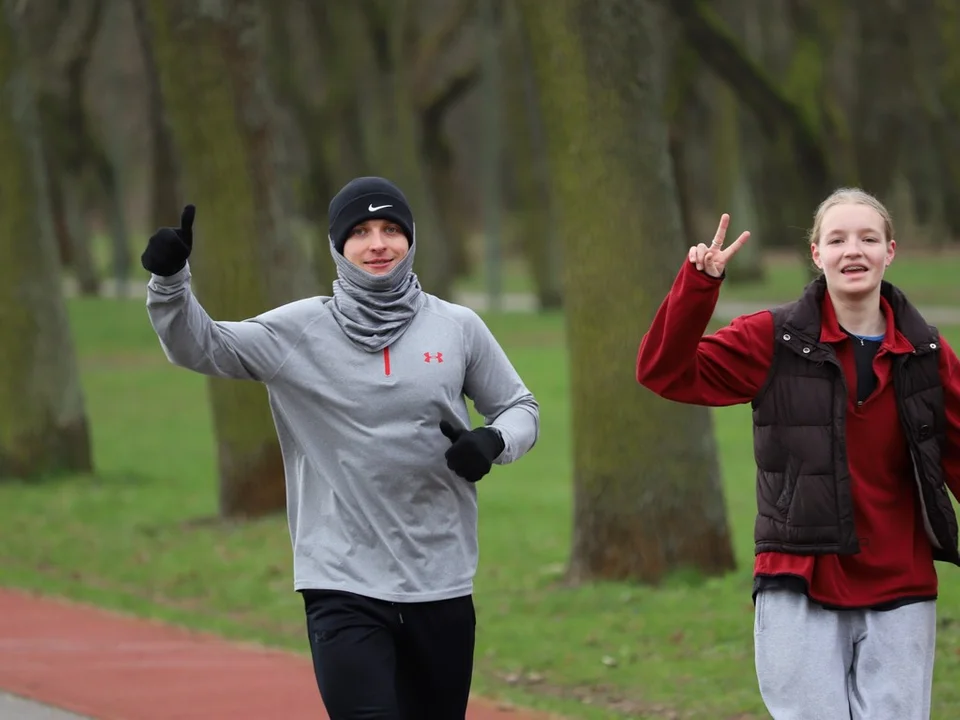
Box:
(147, 265, 539, 602)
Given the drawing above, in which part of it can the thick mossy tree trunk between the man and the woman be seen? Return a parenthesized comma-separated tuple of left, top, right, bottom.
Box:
(521, 0, 734, 583)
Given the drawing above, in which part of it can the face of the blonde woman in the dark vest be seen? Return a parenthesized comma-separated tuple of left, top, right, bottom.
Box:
(810, 203, 897, 298)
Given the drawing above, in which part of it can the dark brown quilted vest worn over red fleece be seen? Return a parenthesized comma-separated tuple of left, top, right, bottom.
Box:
(753, 277, 960, 565)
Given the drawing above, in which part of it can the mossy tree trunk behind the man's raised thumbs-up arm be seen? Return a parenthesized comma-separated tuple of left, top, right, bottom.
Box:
(145, 0, 316, 517)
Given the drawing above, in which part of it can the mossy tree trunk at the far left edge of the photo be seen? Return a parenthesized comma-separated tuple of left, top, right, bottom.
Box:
(0, 0, 92, 480)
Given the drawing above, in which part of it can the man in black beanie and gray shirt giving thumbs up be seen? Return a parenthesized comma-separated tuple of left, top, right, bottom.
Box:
(142, 178, 539, 720)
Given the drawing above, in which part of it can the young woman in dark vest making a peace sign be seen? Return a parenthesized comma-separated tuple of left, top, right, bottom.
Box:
(636, 188, 960, 720)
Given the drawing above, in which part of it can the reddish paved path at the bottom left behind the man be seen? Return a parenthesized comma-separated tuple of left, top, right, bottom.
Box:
(0, 588, 560, 720)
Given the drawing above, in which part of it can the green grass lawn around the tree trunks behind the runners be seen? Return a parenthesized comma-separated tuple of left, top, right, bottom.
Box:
(0, 300, 960, 720)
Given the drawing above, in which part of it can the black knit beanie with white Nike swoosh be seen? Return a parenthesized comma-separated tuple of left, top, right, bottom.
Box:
(329, 177, 413, 255)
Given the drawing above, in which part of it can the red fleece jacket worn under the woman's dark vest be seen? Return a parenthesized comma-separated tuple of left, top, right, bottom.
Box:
(637, 262, 960, 608)
